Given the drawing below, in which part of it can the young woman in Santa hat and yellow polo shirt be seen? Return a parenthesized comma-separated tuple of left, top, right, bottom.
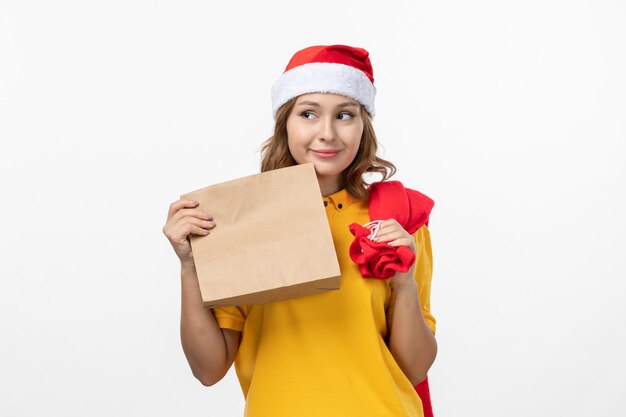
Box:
(163, 45, 437, 417)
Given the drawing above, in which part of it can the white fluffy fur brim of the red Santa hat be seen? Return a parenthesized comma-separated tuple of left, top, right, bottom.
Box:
(272, 62, 376, 120)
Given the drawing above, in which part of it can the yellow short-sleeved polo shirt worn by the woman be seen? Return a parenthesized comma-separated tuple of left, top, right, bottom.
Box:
(213, 189, 435, 417)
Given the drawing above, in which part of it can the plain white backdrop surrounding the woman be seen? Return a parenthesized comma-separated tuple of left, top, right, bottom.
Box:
(0, 0, 626, 417)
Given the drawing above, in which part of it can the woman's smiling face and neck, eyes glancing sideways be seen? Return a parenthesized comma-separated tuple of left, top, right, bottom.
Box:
(287, 93, 363, 193)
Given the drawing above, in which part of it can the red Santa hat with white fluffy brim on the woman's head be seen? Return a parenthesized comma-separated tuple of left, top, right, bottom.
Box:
(272, 45, 376, 119)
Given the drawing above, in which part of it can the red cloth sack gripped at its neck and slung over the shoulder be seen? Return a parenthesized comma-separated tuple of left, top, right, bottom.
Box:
(350, 181, 435, 279)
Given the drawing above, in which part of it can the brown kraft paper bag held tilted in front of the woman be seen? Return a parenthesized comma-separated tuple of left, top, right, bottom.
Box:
(181, 164, 341, 307)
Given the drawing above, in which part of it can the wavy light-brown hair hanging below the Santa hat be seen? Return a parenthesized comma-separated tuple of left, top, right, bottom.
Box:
(261, 98, 396, 200)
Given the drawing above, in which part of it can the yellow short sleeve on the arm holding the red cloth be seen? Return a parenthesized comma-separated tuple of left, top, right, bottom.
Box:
(387, 226, 437, 333)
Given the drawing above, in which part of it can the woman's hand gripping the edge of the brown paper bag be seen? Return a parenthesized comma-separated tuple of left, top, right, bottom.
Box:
(163, 198, 215, 264)
